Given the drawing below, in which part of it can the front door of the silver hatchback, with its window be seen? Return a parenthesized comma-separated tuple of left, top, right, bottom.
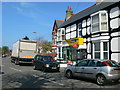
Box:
(74, 60, 88, 77)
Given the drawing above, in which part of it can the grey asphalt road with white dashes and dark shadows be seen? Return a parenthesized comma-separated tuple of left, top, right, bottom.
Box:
(1, 57, 120, 90)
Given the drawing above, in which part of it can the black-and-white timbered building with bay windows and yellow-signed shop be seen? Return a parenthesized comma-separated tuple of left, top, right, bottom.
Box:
(52, 0, 120, 62)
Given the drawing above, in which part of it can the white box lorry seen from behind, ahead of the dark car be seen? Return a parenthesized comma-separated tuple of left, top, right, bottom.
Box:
(11, 39, 37, 65)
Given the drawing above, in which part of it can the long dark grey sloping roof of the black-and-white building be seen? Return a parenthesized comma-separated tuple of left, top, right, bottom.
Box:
(60, 2, 117, 28)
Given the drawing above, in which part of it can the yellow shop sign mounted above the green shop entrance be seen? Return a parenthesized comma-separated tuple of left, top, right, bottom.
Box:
(63, 38, 84, 46)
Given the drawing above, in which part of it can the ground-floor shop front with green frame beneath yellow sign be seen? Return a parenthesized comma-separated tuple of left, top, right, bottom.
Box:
(62, 38, 87, 61)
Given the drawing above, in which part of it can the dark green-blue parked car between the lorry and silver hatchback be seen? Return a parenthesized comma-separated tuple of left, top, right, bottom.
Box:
(33, 55, 60, 71)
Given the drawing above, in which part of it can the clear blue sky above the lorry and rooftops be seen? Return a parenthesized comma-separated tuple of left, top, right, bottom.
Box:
(0, 2, 95, 49)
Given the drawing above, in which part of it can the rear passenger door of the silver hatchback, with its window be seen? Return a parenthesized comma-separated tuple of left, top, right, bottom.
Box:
(83, 60, 100, 79)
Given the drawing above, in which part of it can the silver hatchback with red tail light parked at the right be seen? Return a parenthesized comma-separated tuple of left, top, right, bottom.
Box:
(65, 59, 120, 85)
